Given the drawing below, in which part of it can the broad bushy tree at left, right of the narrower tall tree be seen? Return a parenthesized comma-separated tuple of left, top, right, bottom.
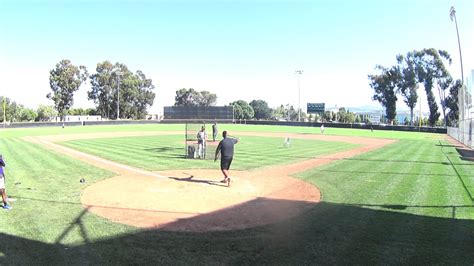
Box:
(88, 61, 155, 119)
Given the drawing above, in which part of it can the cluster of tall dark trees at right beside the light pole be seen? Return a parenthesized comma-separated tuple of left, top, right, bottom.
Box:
(368, 48, 463, 126)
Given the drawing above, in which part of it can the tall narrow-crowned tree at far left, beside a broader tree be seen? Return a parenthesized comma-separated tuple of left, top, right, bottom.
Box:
(46, 59, 88, 119)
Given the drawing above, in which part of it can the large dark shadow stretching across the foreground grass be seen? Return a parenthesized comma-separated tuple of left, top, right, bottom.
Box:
(0, 198, 474, 265)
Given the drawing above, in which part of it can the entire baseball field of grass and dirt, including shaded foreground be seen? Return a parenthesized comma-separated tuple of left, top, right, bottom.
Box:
(0, 124, 474, 265)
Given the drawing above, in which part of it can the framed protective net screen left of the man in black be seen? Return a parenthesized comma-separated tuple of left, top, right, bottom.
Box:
(184, 121, 220, 160)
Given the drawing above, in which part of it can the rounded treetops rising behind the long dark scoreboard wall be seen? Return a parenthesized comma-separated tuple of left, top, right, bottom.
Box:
(174, 88, 217, 106)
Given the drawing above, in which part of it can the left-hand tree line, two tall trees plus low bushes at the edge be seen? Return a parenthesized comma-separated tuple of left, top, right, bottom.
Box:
(0, 59, 155, 122)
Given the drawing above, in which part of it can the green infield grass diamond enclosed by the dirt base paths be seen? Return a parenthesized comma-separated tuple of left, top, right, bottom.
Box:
(63, 135, 357, 170)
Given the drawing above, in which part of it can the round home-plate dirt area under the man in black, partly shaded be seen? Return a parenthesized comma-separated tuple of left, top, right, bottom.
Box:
(81, 170, 320, 231)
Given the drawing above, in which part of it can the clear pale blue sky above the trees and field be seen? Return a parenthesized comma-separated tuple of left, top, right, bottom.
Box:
(0, 0, 474, 113)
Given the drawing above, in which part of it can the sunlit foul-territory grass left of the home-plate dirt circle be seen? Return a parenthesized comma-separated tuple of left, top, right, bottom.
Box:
(0, 138, 135, 264)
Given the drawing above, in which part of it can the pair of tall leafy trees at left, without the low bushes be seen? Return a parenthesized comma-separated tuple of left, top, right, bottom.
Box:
(47, 59, 155, 119)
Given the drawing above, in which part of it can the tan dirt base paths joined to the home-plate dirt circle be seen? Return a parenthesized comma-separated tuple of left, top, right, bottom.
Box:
(25, 132, 394, 231)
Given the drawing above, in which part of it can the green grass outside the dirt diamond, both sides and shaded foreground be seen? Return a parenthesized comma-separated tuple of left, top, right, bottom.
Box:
(0, 125, 474, 265)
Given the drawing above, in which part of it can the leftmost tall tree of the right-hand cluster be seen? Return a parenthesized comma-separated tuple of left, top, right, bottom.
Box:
(368, 66, 399, 123)
